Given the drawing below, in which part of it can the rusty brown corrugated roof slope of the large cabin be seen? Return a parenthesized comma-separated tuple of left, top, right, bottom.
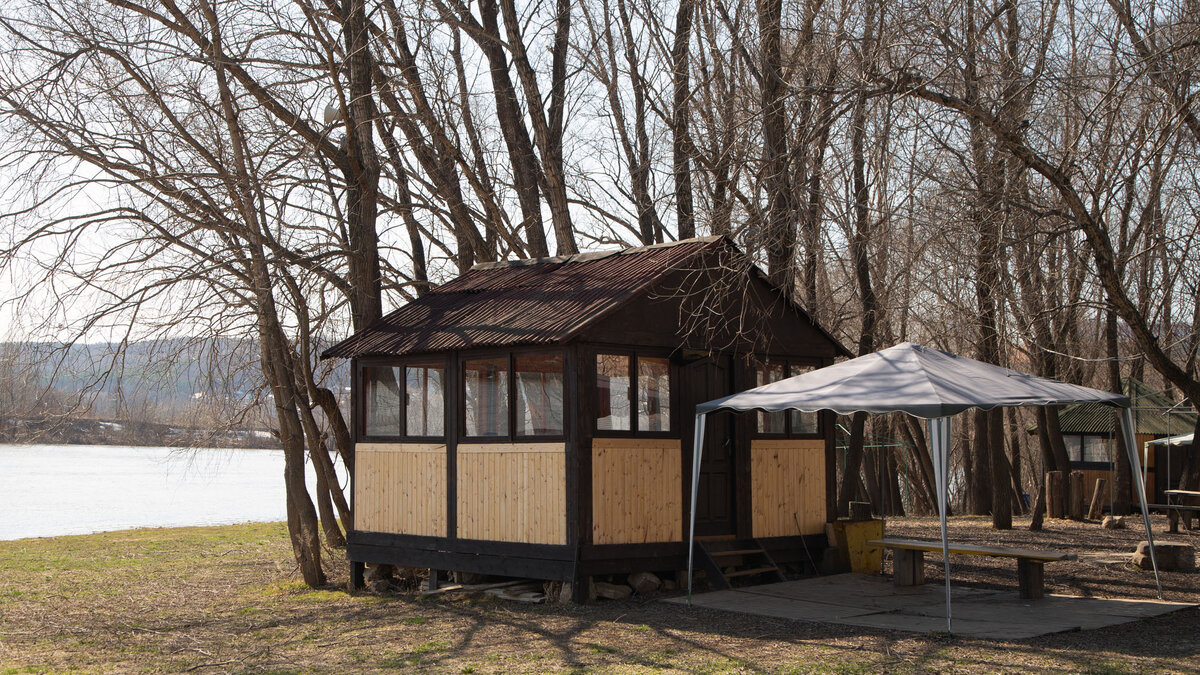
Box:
(322, 237, 733, 358)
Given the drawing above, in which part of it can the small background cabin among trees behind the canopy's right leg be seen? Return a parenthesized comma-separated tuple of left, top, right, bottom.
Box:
(1058, 377, 1196, 503)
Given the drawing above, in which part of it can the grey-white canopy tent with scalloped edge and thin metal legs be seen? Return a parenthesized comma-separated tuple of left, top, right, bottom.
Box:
(688, 342, 1163, 632)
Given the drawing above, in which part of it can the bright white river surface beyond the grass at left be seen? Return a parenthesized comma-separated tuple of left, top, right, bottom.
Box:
(0, 444, 346, 539)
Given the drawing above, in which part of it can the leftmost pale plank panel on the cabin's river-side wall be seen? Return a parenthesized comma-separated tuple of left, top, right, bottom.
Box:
(354, 443, 446, 537)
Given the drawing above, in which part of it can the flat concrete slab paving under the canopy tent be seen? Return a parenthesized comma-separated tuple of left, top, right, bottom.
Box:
(667, 574, 1195, 640)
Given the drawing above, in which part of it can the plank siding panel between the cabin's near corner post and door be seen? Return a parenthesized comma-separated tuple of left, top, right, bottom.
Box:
(592, 438, 683, 544)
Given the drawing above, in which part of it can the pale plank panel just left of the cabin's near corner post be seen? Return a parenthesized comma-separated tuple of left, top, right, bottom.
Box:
(457, 443, 566, 544)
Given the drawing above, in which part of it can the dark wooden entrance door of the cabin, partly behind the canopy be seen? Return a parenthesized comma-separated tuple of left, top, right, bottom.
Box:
(683, 358, 737, 537)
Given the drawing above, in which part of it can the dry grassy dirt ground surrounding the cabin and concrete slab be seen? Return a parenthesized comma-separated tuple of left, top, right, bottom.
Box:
(0, 518, 1200, 674)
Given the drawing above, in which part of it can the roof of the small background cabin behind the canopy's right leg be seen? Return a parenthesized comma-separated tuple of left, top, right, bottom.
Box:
(1058, 377, 1196, 436)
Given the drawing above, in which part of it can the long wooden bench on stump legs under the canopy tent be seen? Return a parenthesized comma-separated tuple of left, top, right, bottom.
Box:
(868, 537, 1076, 599)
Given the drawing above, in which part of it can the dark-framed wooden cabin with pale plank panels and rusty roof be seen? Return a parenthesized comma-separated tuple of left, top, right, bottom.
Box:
(324, 237, 848, 599)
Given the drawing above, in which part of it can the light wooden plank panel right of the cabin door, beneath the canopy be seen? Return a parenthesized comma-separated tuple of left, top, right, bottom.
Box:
(750, 438, 826, 538)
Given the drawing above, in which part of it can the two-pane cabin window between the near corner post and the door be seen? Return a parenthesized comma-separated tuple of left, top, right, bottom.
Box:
(596, 354, 671, 434)
